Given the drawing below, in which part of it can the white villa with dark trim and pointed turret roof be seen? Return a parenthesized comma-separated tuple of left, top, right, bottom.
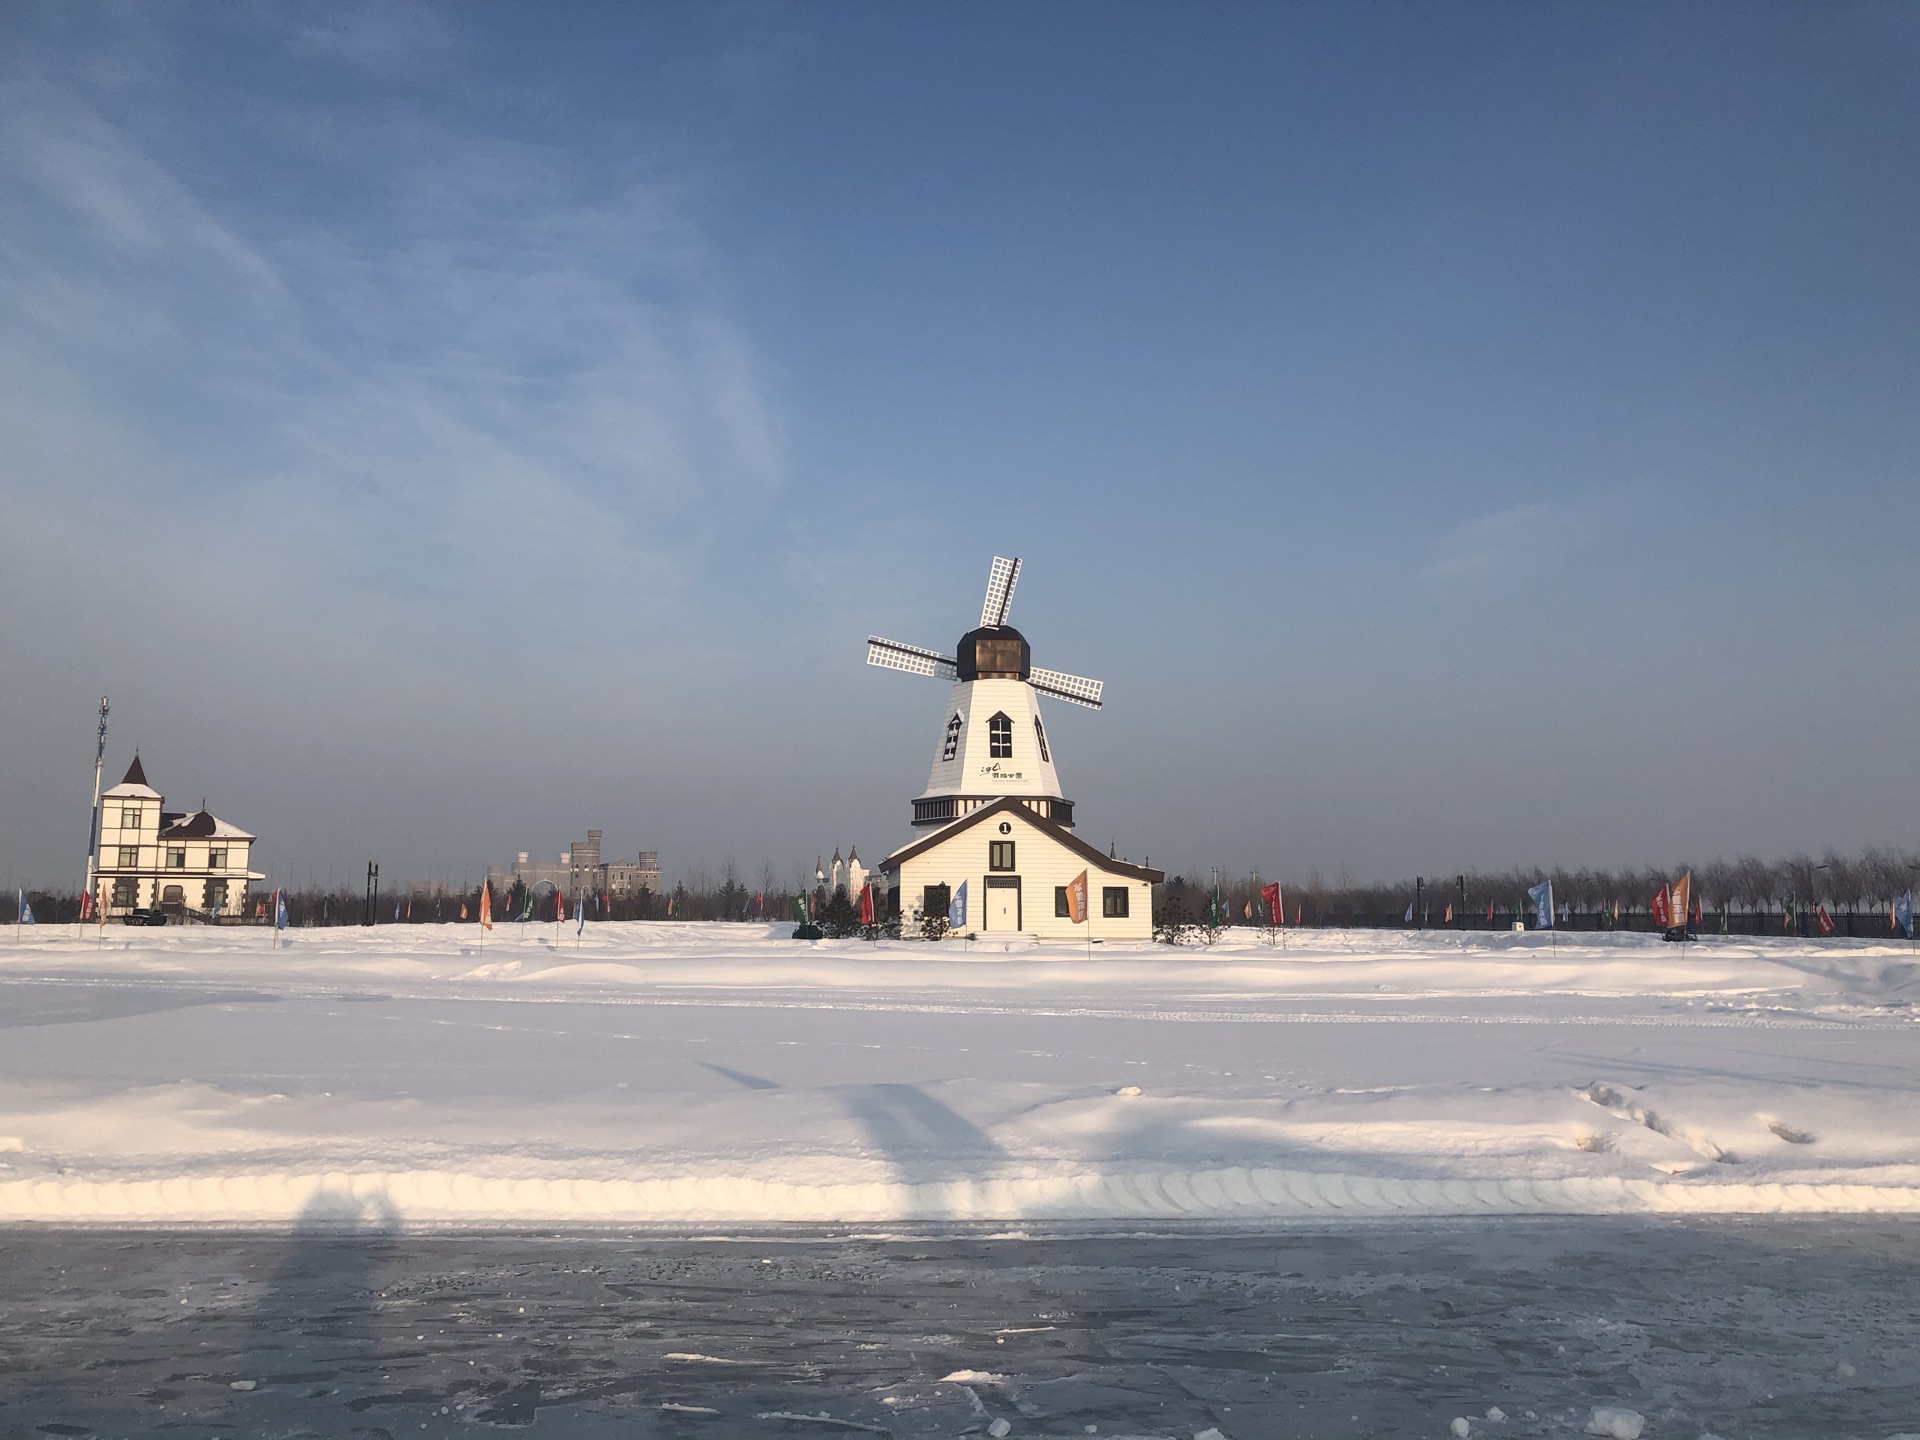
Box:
(94, 755, 265, 920)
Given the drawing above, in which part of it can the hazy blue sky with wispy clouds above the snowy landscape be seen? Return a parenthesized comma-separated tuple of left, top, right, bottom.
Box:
(0, 4, 1920, 898)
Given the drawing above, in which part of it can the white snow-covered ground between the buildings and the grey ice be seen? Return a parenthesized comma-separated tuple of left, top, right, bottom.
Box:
(0, 924, 1920, 1229)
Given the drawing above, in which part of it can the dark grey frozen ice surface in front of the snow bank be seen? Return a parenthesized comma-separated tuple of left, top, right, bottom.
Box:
(0, 1217, 1920, 1440)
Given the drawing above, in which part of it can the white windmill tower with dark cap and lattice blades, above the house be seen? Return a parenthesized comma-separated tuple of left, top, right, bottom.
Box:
(866, 555, 1102, 828)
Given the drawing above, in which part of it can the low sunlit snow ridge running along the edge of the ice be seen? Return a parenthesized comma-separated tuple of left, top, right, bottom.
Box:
(0, 1167, 1920, 1227)
